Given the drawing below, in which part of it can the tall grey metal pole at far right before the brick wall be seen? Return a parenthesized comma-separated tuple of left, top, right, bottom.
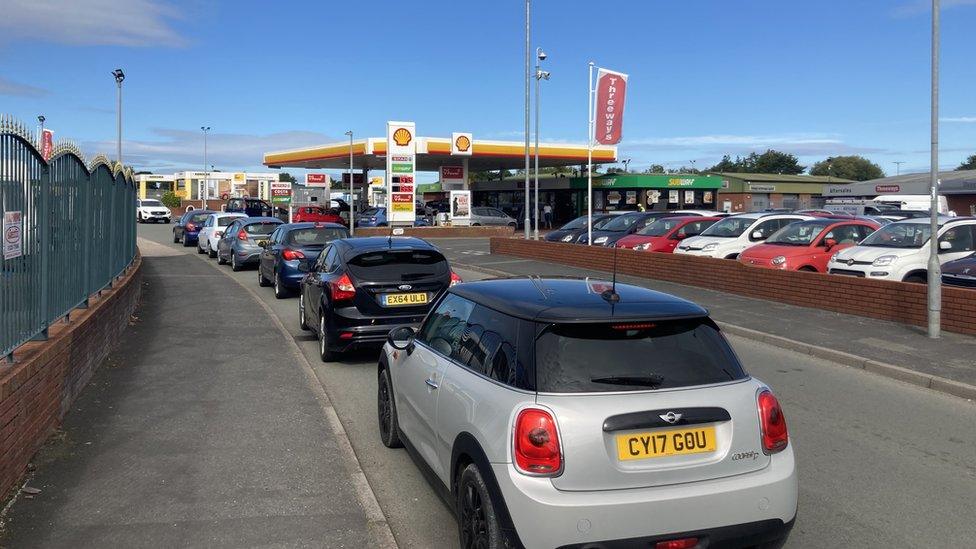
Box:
(928, 0, 942, 338)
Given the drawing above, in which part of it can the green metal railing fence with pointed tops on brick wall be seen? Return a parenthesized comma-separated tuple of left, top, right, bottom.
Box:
(0, 115, 136, 359)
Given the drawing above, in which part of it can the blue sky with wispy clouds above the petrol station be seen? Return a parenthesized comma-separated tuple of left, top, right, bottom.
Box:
(0, 0, 976, 181)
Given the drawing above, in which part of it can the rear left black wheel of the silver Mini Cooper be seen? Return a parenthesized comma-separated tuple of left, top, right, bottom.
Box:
(455, 463, 505, 549)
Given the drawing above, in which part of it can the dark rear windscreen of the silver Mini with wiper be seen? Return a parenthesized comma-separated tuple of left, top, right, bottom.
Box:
(536, 319, 746, 393)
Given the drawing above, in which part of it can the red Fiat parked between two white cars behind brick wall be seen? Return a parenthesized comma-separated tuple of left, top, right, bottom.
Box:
(739, 218, 881, 273)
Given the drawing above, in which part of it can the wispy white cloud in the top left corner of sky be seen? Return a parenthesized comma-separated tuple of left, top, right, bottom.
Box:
(0, 0, 184, 46)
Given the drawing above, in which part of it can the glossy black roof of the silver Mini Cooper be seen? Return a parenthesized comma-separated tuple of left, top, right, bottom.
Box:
(450, 277, 708, 323)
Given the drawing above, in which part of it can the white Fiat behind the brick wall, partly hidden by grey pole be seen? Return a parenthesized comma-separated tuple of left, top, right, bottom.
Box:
(827, 217, 976, 284)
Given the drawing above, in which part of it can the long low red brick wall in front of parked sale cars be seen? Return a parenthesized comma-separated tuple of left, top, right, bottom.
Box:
(491, 238, 976, 335)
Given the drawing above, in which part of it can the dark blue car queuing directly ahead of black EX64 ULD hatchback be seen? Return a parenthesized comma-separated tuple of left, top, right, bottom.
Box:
(257, 223, 349, 299)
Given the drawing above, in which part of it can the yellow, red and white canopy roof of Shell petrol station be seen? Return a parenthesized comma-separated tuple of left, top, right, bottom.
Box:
(264, 137, 617, 172)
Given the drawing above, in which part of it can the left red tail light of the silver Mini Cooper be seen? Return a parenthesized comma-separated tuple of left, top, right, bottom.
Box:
(513, 408, 563, 476)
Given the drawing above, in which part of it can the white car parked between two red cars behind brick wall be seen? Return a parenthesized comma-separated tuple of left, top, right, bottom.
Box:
(674, 212, 816, 259)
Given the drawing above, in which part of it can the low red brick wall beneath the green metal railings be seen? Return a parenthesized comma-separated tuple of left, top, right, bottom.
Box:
(0, 256, 142, 494)
